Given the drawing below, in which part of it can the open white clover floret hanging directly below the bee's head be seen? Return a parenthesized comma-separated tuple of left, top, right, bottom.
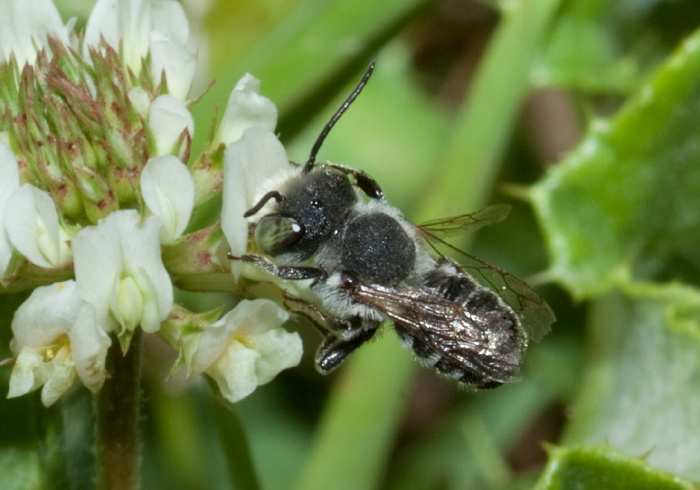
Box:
(184, 299, 302, 402)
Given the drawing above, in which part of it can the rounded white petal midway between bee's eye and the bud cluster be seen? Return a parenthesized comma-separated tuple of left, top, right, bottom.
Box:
(141, 155, 194, 243)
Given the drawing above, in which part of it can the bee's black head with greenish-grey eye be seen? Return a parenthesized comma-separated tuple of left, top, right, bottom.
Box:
(246, 166, 357, 262)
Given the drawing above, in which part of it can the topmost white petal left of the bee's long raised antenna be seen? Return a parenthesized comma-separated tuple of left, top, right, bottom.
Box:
(216, 74, 277, 145)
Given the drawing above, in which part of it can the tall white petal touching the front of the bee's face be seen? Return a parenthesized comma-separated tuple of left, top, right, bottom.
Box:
(221, 128, 290, 264)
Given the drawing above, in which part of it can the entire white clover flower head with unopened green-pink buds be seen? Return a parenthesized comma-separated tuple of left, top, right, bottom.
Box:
(0, 0, 301, 406)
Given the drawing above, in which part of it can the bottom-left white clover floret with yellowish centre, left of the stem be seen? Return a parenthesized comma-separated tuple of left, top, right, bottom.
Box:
(7, 281, 112, 407)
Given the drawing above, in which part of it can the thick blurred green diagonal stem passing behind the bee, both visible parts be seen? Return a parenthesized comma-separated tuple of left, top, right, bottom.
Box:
(296, 0, 559, 490)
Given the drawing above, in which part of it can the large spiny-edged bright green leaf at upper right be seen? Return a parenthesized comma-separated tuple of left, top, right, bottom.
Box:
(531, 31, 700, 297)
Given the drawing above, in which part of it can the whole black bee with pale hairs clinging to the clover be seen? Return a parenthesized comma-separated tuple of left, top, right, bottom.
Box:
(231, 64, 554, 389)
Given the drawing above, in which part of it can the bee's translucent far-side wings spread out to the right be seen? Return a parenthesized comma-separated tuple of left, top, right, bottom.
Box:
(416, 216, 555, 341)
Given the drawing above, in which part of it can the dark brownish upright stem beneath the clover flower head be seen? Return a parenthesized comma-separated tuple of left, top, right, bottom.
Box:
(96, 328, 141, 490)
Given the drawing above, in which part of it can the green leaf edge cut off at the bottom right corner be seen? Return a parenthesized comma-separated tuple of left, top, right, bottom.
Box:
(535, 446, 697, 490)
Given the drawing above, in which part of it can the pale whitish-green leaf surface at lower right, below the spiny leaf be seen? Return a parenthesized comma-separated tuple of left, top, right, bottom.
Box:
(564, 284, 700, 478)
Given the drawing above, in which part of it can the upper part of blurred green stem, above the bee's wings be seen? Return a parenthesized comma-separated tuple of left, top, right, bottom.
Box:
(415, 0, 560, 223)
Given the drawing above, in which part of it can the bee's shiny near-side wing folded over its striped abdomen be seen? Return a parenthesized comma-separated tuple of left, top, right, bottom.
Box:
(353, 283, 524, 387)
